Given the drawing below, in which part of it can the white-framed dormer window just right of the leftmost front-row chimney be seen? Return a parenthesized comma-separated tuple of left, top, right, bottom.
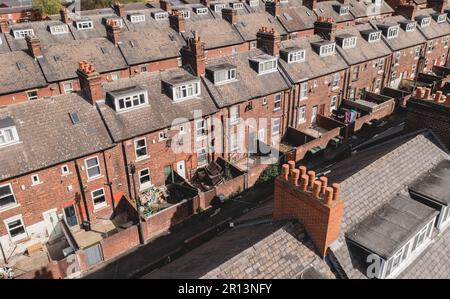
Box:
(107, 86, 148, 112)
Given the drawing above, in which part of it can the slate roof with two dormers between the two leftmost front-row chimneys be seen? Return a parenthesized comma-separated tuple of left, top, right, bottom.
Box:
(99, 69, 217, 141)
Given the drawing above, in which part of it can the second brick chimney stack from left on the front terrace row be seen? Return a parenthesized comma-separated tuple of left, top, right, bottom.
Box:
(181, 32, 206, 76)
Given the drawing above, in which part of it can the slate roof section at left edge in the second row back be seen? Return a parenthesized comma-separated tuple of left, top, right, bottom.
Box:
(0, 51, 47, 94)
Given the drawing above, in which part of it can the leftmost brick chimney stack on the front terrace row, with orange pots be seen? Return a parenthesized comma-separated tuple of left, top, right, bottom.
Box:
(77, 60, 104, 105)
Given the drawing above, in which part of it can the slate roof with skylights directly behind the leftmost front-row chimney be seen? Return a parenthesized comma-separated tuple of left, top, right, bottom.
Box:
(38, 38, 127, 82)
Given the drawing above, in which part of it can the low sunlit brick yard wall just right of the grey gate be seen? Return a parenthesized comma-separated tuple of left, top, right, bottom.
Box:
(100, 225, 139, 261)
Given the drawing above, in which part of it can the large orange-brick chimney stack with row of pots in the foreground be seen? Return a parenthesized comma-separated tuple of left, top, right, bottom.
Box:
(273, 164, 344, 257)
